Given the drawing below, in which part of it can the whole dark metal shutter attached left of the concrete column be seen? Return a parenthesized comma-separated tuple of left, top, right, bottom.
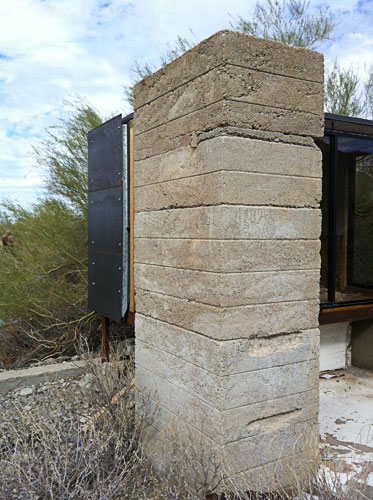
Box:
(88, 115, 128, 322)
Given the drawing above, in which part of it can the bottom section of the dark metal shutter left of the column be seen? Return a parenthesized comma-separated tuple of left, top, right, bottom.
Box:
(88, 253, 122, 322)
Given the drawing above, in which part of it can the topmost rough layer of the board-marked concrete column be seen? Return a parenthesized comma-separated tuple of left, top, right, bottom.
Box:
(134, 30, 324, 107)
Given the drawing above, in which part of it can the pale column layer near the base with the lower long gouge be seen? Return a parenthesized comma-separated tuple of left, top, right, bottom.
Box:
(138, 366, 319, 445)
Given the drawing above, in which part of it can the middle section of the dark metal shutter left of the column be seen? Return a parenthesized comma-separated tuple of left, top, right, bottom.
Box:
(88, 187, 123, 255)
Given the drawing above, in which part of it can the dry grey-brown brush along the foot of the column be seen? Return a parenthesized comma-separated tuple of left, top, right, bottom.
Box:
(0, 352, 371, 500)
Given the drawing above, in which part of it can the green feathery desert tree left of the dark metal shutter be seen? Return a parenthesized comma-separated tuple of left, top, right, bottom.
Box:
(0, 99, 102, 364)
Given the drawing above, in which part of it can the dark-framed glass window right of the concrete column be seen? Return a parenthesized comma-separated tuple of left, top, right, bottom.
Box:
(318, 135, 373, 304)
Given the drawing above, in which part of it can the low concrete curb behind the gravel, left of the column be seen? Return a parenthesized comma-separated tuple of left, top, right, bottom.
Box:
(0, 360, 86, 393)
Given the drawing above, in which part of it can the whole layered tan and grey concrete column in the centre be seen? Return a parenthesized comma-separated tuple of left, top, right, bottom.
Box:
(134, 31, 324, 484)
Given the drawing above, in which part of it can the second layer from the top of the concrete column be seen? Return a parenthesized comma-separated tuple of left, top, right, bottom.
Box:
(136, 64, 323, 134)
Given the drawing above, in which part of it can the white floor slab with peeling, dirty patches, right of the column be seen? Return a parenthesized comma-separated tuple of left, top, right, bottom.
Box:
(320, 368, 373, 498)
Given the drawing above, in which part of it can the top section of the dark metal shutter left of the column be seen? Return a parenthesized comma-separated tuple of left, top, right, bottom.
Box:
(88, 115, 123, 191)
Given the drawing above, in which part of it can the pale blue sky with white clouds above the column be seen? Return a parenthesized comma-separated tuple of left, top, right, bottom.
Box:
(0, 0, 373, 205)
